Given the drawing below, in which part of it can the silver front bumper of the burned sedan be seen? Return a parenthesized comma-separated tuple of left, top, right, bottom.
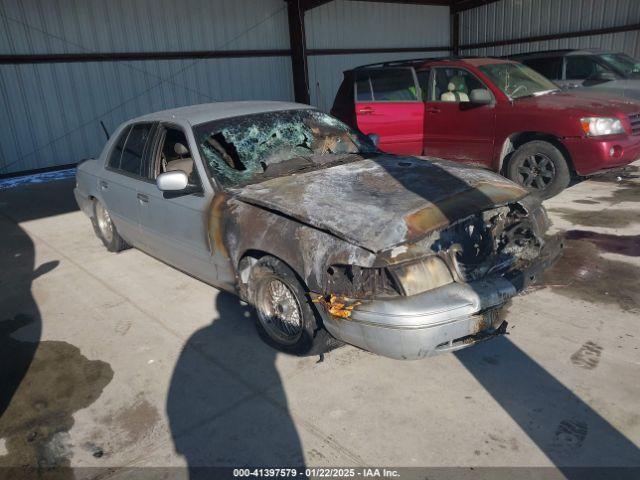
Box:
(323, 237, 562, 360)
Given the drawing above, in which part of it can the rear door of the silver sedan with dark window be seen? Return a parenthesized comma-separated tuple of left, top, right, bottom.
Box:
(98, 122, 153, 247)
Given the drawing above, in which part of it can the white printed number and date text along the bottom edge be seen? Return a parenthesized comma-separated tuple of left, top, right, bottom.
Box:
(233, 468, 400, 478)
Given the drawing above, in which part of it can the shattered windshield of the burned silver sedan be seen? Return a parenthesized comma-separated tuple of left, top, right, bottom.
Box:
(194, 110, 375, 187)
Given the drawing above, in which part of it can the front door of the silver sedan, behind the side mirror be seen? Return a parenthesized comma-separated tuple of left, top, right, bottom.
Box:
(137, 124, 217, 284)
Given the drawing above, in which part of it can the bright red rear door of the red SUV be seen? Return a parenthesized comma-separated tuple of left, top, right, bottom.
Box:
(355, 68, 424, 155)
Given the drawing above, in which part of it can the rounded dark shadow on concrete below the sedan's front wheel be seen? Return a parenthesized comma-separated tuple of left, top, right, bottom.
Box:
(167, 292, 304, 479)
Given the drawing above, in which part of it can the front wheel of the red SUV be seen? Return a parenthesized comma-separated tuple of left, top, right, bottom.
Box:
(507, 140, 571, 199)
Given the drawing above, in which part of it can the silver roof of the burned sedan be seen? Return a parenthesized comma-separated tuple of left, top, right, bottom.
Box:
(131, 101, 313, 125)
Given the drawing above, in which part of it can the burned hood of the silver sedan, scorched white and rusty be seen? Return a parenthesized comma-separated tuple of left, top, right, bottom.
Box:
(230, 155, 527, 252)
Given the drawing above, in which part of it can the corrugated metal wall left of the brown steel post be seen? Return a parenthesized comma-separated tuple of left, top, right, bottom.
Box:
(0, 0, 293, 174)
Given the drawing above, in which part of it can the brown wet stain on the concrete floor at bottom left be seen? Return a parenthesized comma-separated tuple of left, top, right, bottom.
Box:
(0, 318, 113, 468)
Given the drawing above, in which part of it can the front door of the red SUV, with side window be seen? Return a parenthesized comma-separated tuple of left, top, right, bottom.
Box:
(424, 67, 495, 166)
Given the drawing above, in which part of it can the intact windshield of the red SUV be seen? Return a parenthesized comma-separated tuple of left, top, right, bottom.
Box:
(480, 63, 558, 99)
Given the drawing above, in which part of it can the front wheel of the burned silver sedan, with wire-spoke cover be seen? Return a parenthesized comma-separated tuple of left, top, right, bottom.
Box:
(248, 256, 342, 355)
